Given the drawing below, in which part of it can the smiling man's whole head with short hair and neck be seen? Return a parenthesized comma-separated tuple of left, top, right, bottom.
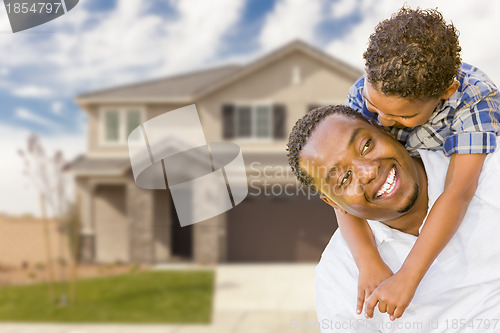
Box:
(289, 106, 427, 235)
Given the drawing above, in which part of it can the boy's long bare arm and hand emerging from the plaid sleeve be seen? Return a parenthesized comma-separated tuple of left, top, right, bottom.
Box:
(366, 154, 486, 320)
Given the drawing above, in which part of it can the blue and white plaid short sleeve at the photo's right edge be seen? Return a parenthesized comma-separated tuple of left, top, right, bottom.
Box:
(443, 87, 500, 156)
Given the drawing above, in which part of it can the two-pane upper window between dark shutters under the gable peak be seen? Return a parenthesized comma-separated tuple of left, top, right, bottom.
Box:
(235, 105, 272, 139)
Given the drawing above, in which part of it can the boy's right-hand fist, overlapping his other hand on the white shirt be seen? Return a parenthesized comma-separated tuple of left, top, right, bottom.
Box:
(365, 271, 418, 320)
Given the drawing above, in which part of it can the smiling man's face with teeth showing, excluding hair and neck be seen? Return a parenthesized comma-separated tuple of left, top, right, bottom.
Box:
(300, 114, 419, 221)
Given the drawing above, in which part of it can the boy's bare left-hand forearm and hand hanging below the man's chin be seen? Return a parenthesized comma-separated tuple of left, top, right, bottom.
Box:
(335, 209, 392, 314)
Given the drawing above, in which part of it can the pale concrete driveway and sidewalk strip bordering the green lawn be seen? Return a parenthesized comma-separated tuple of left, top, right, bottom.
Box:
(0, 264, 319, 333)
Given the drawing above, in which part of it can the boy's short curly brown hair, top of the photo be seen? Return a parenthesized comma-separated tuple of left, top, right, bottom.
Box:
(363, 6, 461, 100)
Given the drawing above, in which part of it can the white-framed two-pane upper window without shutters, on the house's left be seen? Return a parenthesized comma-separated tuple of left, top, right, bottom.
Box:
(101, 108, 144, 144)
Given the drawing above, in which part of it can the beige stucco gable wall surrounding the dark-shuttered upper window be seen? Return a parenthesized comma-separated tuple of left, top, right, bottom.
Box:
(196, 51, 355, 151)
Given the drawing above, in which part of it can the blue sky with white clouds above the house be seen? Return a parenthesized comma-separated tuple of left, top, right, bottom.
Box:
(0, 0, 500, 215)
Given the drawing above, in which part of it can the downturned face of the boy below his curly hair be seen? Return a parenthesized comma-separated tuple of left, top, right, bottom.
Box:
(363, 79, 441, 128)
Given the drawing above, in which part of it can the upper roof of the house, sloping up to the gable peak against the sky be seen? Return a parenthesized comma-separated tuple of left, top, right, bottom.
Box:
(76, 40, 362, 105)
